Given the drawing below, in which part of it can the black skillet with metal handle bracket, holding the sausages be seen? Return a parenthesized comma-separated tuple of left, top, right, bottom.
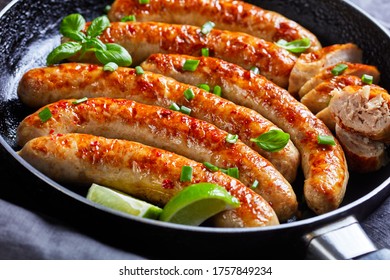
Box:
(0, 0, 390, 259)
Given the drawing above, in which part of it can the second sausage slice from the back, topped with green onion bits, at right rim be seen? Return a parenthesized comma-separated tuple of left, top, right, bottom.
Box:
(299, 62, 380, 101)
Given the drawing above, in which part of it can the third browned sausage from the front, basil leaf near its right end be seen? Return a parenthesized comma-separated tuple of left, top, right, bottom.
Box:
(18, 63, 299, 186)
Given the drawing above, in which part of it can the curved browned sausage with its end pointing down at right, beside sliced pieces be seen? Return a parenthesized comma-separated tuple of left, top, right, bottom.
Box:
(142, 54, 348, 214)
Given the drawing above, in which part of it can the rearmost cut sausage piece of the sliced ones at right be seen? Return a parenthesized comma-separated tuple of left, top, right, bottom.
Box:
(288, 43, 362, 97)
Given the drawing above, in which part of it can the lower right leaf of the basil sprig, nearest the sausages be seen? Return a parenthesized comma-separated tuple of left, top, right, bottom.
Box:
(96, 44, 133, 66)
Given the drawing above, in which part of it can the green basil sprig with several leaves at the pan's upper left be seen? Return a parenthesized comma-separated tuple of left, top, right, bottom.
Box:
(46, 14, 132, 66)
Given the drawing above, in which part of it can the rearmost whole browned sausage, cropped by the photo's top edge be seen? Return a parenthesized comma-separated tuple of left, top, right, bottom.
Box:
(108, 0, 321, 51)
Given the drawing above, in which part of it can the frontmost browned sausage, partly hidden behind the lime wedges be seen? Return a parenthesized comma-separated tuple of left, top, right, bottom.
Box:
(19, 134, 278, 227)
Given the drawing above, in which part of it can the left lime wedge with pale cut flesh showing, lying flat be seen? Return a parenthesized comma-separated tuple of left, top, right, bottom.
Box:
(87, 184, 162, 219)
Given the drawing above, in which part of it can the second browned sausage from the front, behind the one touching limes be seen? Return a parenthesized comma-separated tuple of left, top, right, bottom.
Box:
(17, 98, 298, 221)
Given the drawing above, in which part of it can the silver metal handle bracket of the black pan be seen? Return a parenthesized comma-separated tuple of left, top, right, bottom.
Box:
(304, 216, 390, 260)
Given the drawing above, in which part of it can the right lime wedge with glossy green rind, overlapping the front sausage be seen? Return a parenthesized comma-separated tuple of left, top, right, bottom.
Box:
(160, 183, 240, 226)
